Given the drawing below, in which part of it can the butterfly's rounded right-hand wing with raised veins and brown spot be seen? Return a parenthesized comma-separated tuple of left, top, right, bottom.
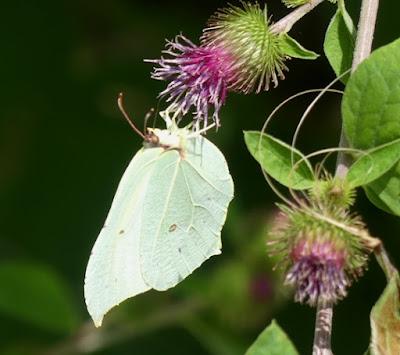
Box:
(140, 136, 233, 290)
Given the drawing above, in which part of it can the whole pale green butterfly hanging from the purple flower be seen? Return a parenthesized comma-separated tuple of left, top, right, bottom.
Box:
(84, 96, 233, 326)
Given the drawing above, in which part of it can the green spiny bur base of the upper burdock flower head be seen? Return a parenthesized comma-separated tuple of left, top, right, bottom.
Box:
(201, 2, 288, 93)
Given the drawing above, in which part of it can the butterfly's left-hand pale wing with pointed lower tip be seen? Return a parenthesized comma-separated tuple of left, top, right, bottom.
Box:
(84, 148, 163, 326)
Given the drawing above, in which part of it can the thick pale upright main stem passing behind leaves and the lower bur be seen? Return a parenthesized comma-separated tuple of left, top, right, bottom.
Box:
(313, 0, 378, 355)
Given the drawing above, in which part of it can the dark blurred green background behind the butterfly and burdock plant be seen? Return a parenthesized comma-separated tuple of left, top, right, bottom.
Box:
(0, 0, 400, 355)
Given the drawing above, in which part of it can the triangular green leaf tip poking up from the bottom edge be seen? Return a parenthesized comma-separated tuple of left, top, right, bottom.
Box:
(245, 320, 298, 355)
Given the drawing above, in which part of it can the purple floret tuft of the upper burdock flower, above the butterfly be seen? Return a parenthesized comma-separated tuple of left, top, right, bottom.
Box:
(147, 35, 238, 127)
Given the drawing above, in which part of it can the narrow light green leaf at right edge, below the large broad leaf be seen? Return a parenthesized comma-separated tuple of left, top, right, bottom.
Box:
(346, 139, 400, 187)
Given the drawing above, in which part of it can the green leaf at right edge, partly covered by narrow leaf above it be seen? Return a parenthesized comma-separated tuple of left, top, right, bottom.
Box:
(366, 163, 400, 216)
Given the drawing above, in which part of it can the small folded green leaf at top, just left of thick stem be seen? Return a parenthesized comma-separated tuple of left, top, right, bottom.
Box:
(324, 2, 355, 83)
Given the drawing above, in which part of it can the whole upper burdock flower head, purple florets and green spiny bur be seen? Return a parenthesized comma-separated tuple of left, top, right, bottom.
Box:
(150, 3, 287, 127)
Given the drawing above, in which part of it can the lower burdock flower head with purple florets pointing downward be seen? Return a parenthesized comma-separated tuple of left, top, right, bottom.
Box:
(268, 180, 371, 306)
